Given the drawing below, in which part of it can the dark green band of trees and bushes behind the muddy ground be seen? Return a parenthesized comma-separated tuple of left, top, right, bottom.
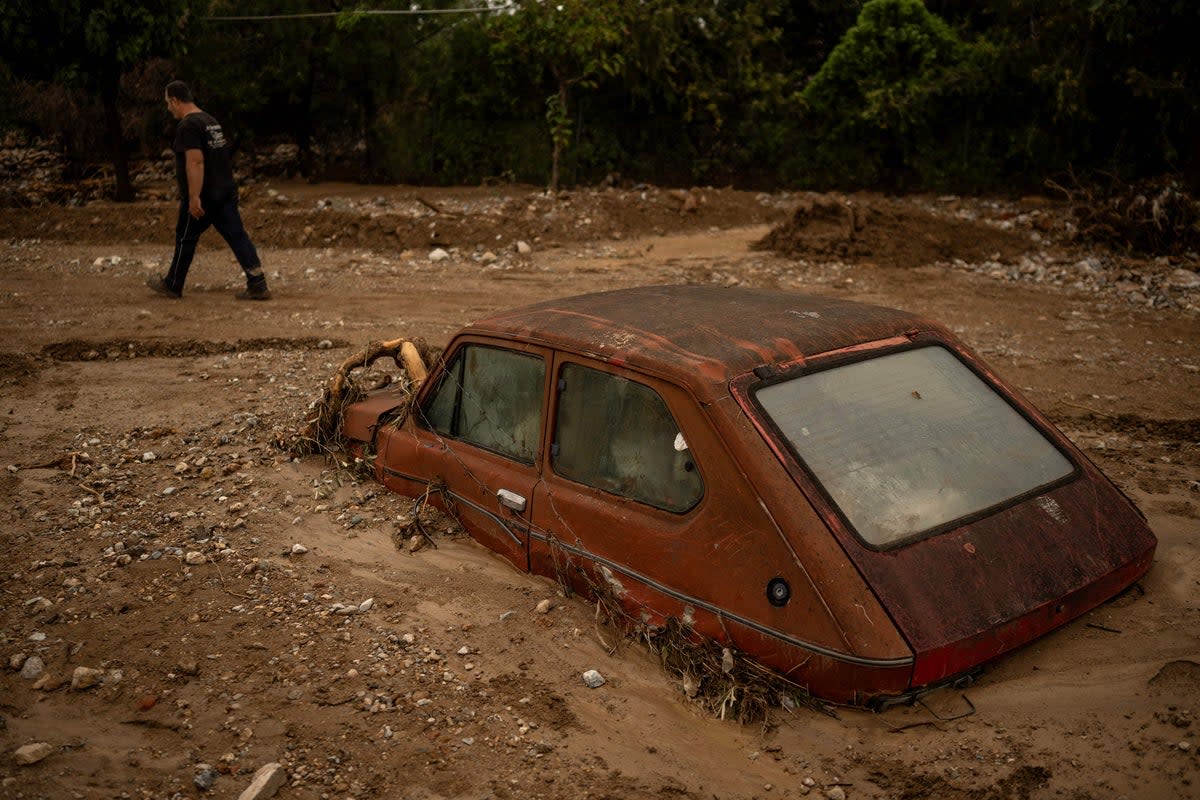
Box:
(0, 0, 1200, 197)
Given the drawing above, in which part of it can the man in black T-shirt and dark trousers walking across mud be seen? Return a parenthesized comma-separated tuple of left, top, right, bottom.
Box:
(146, 80, 271, 300)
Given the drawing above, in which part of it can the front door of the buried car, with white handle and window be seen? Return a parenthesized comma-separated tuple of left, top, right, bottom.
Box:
(396, 339, 550, 570)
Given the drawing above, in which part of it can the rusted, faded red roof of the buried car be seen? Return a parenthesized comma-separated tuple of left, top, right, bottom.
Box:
(466, 285, 942, 386)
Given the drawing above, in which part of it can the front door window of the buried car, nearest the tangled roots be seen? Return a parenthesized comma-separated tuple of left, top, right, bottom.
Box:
(422, 344, 546, 464)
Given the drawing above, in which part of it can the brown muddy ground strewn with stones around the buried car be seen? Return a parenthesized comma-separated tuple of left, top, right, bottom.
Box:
(0, 184, 1200, 800)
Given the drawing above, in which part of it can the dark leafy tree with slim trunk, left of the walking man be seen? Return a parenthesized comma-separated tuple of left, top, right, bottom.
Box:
(0, 0, 190, 200)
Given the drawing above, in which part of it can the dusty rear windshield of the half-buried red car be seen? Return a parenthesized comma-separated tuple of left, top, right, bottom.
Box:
(755, 347, 1074, 547)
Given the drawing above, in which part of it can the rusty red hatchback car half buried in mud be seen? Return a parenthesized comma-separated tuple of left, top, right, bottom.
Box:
(342, 285, 1156, 708)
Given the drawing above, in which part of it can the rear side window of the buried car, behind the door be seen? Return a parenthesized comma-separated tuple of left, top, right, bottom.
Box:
(551, 363, 704, 512)
